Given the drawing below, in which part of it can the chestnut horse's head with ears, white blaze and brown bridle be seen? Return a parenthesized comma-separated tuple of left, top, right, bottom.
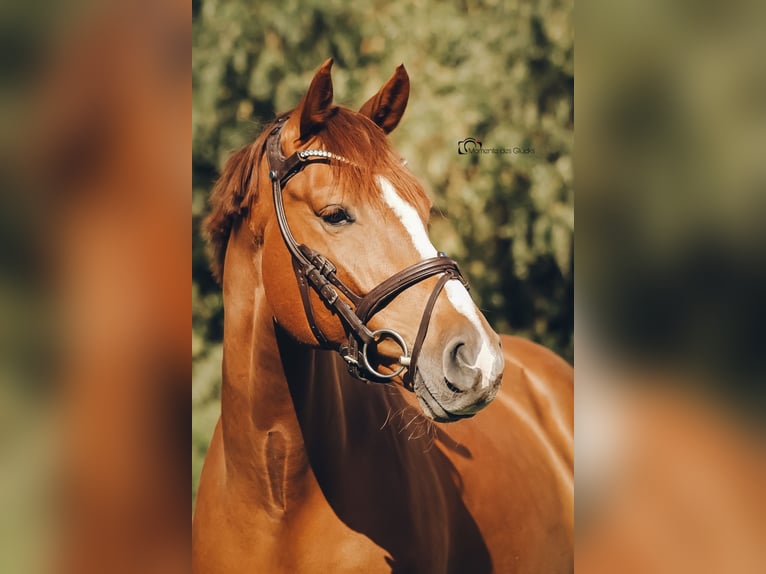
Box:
(210, 60, 503, 421)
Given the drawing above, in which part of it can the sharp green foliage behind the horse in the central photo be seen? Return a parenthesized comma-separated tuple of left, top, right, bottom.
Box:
(192, 0, 574, 504)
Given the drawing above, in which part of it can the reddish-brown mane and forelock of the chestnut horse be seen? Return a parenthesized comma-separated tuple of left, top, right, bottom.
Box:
(202, 107, 430, 283)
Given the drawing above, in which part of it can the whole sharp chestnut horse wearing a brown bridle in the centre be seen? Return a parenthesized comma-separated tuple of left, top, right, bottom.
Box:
(193, 60, 573, 574)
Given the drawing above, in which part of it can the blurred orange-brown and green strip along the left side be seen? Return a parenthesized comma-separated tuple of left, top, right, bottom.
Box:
(0, 0, 191, 574)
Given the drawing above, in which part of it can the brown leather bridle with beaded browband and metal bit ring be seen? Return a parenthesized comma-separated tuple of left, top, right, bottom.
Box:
(266, 116, 468, 389)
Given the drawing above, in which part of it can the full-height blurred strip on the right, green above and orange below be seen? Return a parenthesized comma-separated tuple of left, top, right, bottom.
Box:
(575, 0, 766, 574)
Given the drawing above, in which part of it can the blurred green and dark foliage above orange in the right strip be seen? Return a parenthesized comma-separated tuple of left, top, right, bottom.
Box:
(577, 1, 766, 410)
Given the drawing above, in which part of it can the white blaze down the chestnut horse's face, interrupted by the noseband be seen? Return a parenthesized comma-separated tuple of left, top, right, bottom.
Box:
(378, 176, 504, 387)
